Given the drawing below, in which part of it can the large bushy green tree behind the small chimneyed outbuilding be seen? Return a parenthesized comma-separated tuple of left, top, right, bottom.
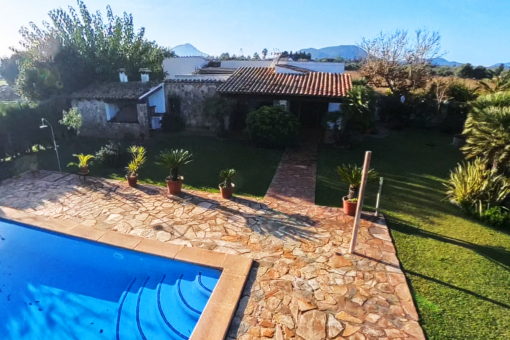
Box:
(15, 0, 169, 100)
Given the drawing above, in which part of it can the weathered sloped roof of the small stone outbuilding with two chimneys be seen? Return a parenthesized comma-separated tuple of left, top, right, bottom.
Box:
(69, 81, 161, 100)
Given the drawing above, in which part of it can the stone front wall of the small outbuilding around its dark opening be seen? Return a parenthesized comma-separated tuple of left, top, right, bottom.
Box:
(72, 100, 149, 139)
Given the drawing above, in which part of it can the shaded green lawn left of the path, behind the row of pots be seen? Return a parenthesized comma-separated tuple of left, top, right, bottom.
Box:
(37, 134, 283, 197)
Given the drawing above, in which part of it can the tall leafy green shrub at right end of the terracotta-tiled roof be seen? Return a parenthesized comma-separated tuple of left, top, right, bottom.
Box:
(343, 85, 375, 131)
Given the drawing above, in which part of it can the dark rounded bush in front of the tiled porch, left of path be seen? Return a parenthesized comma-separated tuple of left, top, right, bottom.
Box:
(246, 106, 301, 147)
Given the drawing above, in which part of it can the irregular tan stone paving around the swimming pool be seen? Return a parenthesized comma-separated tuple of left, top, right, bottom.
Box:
(0, 167, 425, 340)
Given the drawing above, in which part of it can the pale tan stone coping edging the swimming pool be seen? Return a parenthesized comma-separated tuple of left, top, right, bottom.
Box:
(0, 206, 253, 340)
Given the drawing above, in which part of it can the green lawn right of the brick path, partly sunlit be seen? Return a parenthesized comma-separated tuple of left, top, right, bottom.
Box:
(316, 130, 510, 340)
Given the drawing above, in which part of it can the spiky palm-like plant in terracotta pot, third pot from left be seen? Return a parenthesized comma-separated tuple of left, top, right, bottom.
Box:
(156, 150, 193, 195)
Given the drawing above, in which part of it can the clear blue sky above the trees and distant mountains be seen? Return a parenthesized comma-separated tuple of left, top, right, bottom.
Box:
(0, 0, 510, 65)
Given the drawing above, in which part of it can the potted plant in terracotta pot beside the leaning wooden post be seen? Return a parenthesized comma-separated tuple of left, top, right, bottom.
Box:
(337, 164, 379, 216)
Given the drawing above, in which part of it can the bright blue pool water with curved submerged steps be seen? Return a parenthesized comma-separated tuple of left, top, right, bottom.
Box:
(0, 219, 221, 340)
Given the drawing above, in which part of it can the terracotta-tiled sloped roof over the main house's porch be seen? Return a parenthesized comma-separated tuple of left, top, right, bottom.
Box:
(217, 67, 352, 98)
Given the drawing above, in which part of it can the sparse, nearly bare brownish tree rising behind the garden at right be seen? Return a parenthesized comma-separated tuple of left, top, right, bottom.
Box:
(359, 29, 441, 94)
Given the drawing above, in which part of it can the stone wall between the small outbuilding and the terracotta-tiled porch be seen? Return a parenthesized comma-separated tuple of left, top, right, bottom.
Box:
(165, 80, 222, 130)
